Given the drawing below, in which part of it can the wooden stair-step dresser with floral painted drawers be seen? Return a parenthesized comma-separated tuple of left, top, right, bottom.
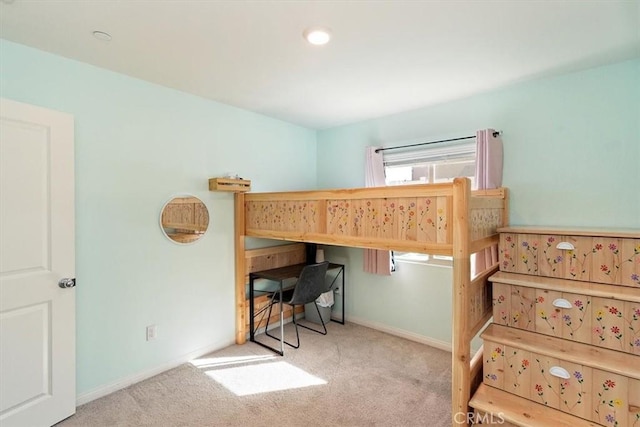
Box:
(470, 227, 640, 427)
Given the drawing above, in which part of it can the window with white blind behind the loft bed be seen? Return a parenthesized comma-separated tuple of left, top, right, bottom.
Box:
(384, 139, 476, 266)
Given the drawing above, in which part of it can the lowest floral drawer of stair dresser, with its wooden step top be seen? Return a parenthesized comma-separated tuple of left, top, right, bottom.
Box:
(482, 325, 640, 426)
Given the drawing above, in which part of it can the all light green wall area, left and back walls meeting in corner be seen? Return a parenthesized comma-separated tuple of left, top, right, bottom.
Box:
(0, 36, 640, 395)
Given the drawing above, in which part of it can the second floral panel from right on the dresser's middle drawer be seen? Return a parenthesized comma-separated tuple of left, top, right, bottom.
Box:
(591, 297, 628, 351)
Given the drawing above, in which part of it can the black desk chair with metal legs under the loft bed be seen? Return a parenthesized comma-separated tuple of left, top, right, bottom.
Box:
(265, 261, 329, 348)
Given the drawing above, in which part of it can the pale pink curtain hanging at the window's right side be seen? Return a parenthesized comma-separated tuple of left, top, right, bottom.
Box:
(471, 129, 503, 275)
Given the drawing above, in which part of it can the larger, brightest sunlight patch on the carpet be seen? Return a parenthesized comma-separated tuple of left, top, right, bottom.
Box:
(206, 362, 327, 396)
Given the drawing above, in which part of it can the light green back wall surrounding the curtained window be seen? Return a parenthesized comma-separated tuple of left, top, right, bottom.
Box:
(318, 60, 640, 342)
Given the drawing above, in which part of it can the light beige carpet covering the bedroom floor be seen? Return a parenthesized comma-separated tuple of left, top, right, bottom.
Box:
(58, 322, 451, 427)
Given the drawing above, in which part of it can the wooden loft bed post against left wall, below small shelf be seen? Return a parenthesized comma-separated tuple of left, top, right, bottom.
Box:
(233, 193, 247, 344)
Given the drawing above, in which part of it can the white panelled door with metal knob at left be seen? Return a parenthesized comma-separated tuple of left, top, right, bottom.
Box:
(0, 99, 76, 427)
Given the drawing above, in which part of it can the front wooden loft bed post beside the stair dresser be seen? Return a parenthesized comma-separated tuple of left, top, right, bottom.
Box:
(451, 178, 471, 425)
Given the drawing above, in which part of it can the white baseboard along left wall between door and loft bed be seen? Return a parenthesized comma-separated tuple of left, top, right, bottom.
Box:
(76, 340, 235, 406)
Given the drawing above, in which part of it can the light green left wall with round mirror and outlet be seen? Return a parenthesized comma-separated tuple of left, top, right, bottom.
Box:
(0, 41, 316, 395)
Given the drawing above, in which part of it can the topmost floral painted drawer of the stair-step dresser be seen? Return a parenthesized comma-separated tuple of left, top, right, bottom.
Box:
(499, 232, 640, 287)
